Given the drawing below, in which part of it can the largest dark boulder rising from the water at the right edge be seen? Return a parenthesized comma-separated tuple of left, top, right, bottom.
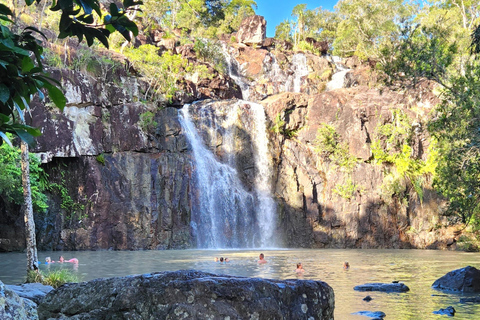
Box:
(432, 266, 480, 293)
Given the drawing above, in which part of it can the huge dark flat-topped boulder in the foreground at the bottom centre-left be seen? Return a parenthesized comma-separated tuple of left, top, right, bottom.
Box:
(38, 270, 334, 320)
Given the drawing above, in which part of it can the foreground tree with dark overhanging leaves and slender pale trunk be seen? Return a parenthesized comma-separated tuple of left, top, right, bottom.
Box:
(0, 0, 142, 271)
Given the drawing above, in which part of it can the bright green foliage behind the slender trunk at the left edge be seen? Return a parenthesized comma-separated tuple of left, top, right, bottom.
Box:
(0, 136, 48, 212)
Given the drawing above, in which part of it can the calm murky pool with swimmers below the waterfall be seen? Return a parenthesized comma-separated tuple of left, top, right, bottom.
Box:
(0, 249, 480, 320)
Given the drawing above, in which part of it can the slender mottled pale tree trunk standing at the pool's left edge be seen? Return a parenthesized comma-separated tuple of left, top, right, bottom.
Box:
(21, 141, 38, 272)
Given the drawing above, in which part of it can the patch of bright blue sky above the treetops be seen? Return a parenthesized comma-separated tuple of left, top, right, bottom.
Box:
(256, 0, 338, 37)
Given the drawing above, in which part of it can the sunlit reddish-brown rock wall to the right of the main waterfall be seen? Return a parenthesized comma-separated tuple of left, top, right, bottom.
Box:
(261, 86, 455, 248)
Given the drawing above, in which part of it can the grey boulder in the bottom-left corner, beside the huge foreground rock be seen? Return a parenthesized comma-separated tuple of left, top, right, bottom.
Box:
(0, 281, 38, 320)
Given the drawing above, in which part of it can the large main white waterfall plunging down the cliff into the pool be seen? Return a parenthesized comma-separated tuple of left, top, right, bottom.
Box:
(180, 101, 276, 248)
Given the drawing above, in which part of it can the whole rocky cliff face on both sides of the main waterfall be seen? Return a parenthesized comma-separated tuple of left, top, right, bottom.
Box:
(0, 46, 454, 251)
